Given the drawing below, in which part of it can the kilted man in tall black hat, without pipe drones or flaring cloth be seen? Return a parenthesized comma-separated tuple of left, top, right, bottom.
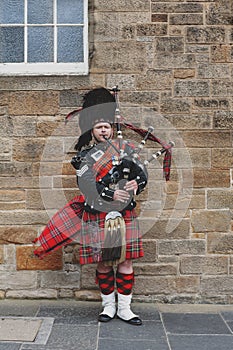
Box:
(72, 88, 147, 325)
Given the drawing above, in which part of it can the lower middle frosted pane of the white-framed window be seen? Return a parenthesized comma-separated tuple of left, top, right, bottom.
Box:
(28, 27, 53, 62)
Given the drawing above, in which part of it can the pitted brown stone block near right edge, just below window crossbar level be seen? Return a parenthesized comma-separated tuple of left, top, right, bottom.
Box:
(187, 26, 226, 44)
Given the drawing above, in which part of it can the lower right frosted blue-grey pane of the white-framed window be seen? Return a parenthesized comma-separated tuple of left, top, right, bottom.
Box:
(57, 27, 83, 62)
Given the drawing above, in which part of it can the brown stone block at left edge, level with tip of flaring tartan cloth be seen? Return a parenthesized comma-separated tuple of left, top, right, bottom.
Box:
(0, 226, 37, 244)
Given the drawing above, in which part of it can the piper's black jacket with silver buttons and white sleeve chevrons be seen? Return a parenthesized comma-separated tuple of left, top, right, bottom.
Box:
(71, 142, 147, 213)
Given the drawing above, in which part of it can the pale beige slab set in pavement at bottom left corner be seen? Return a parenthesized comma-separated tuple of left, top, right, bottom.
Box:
(0, 318, 42, 342)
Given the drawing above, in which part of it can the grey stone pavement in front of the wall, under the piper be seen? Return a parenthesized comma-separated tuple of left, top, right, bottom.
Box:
(0, 299, 233, 350)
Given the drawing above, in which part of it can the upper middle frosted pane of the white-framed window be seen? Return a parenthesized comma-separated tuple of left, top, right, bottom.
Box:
(28, 0, 53, 24)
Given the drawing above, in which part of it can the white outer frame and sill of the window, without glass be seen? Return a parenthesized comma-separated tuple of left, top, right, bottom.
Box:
(0, 0, 89, 76)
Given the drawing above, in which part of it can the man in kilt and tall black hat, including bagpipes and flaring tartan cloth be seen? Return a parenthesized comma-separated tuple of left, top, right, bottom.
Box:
(34, 88, 174, 325)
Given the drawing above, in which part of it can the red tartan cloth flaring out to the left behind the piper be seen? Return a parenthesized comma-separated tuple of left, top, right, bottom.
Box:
(34, 195, 85, 258)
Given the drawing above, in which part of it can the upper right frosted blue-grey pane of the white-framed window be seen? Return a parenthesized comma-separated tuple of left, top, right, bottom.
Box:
(57, 0, 83, 24)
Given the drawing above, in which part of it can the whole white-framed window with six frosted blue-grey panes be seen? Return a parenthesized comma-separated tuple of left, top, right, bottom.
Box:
(0, 0, 88, 75)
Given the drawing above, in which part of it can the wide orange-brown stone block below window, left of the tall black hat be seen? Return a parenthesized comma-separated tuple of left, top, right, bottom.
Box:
(9, 90, 59, 115)
